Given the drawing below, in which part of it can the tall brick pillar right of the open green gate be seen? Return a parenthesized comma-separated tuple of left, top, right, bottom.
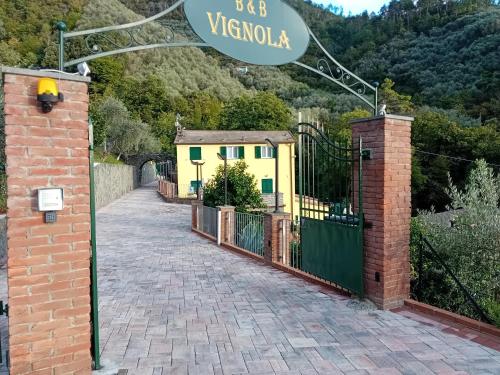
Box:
(352, 115, 413, 309)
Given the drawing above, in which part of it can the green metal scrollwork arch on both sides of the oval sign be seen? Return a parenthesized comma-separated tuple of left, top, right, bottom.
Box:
(57, 0, 377, 113)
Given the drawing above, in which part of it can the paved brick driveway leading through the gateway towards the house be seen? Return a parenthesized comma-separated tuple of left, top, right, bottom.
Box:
(96, 189, 500, 375)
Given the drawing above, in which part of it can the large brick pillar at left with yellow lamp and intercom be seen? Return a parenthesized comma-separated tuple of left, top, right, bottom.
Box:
(1, 68, 91, 375)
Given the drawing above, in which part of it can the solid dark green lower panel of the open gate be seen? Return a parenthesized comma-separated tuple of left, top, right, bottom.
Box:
(301, 217, 363, 297)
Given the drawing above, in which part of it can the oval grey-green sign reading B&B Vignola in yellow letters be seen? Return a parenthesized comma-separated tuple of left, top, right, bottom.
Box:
(184, 0, 309, 65)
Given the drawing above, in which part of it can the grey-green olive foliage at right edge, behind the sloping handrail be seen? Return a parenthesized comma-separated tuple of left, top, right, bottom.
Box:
(412, 160, 500, 326)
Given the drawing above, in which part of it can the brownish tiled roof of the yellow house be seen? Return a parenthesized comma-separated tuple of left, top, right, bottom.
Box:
(174, 130, 295, 145)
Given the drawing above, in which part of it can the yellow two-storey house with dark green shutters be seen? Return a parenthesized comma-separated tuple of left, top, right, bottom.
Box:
(174, 130, 298, 217)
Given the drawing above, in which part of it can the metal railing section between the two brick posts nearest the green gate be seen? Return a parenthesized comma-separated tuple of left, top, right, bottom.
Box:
(234, 212, 264, 256)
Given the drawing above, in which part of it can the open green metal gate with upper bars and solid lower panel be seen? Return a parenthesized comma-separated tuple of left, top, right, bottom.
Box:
(297, 123, 363, 297)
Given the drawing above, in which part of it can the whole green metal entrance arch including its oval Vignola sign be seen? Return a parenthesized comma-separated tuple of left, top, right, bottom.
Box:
(57, 0, 377, 114)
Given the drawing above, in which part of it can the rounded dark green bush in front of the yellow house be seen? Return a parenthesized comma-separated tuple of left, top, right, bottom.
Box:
(203, 160, 265, 212)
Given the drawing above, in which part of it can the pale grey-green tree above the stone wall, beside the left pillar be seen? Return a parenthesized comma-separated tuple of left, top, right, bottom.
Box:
(97, 97, 160, 160)
